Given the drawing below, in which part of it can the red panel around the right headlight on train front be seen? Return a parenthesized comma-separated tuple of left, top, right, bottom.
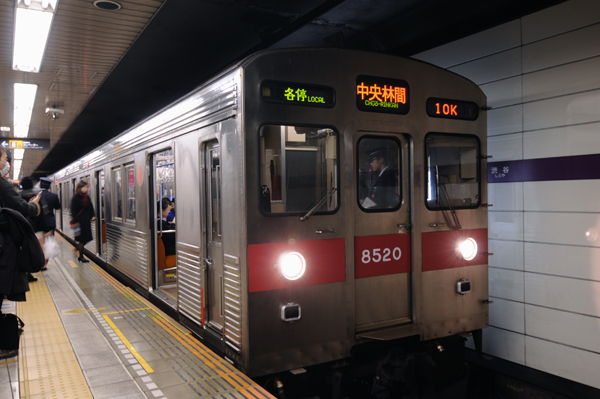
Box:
(422, 229, 488, 272)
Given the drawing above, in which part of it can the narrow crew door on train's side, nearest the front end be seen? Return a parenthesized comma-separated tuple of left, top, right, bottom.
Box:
(203, 141, 224, 332)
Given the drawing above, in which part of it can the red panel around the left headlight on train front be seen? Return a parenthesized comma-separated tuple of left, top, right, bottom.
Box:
(248, 238, 346, 292)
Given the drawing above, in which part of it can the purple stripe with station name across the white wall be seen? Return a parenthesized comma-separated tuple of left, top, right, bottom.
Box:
(488, 154, 600, 183)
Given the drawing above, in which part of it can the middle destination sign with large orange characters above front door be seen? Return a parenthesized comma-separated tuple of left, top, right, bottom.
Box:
(356, 75, 410, 115)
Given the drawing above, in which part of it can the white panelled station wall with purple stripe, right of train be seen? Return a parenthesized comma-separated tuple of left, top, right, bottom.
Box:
(414, 0, 600, 388)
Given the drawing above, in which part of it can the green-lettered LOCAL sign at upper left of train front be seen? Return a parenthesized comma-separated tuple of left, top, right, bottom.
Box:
(260, 80, 335, 108)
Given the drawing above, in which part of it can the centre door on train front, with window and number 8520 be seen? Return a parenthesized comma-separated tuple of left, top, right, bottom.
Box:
(354, 133, 412, 338)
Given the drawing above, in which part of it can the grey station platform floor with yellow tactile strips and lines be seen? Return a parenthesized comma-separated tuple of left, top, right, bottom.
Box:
(0, 234, 273, 399)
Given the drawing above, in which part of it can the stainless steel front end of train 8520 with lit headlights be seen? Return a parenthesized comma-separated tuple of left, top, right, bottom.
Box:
(238, 49, 488, 376)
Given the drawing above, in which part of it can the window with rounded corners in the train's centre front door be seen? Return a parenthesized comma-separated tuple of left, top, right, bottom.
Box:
(356, 136, 402, 212)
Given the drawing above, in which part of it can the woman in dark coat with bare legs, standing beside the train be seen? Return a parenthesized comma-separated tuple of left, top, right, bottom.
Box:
(71, 180, 96, 262)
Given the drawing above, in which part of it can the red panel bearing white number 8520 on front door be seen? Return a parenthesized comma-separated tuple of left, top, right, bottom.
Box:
(354, 234, 410, 278)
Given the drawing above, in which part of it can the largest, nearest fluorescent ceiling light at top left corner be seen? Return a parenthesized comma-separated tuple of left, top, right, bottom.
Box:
(13, 0, 58, 72)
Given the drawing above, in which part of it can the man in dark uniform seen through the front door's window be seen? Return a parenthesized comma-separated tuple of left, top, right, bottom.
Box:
(370, 151, 399, 209)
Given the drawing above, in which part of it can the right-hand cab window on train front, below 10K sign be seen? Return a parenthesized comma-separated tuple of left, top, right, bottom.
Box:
(425, 133, 481, 210)
